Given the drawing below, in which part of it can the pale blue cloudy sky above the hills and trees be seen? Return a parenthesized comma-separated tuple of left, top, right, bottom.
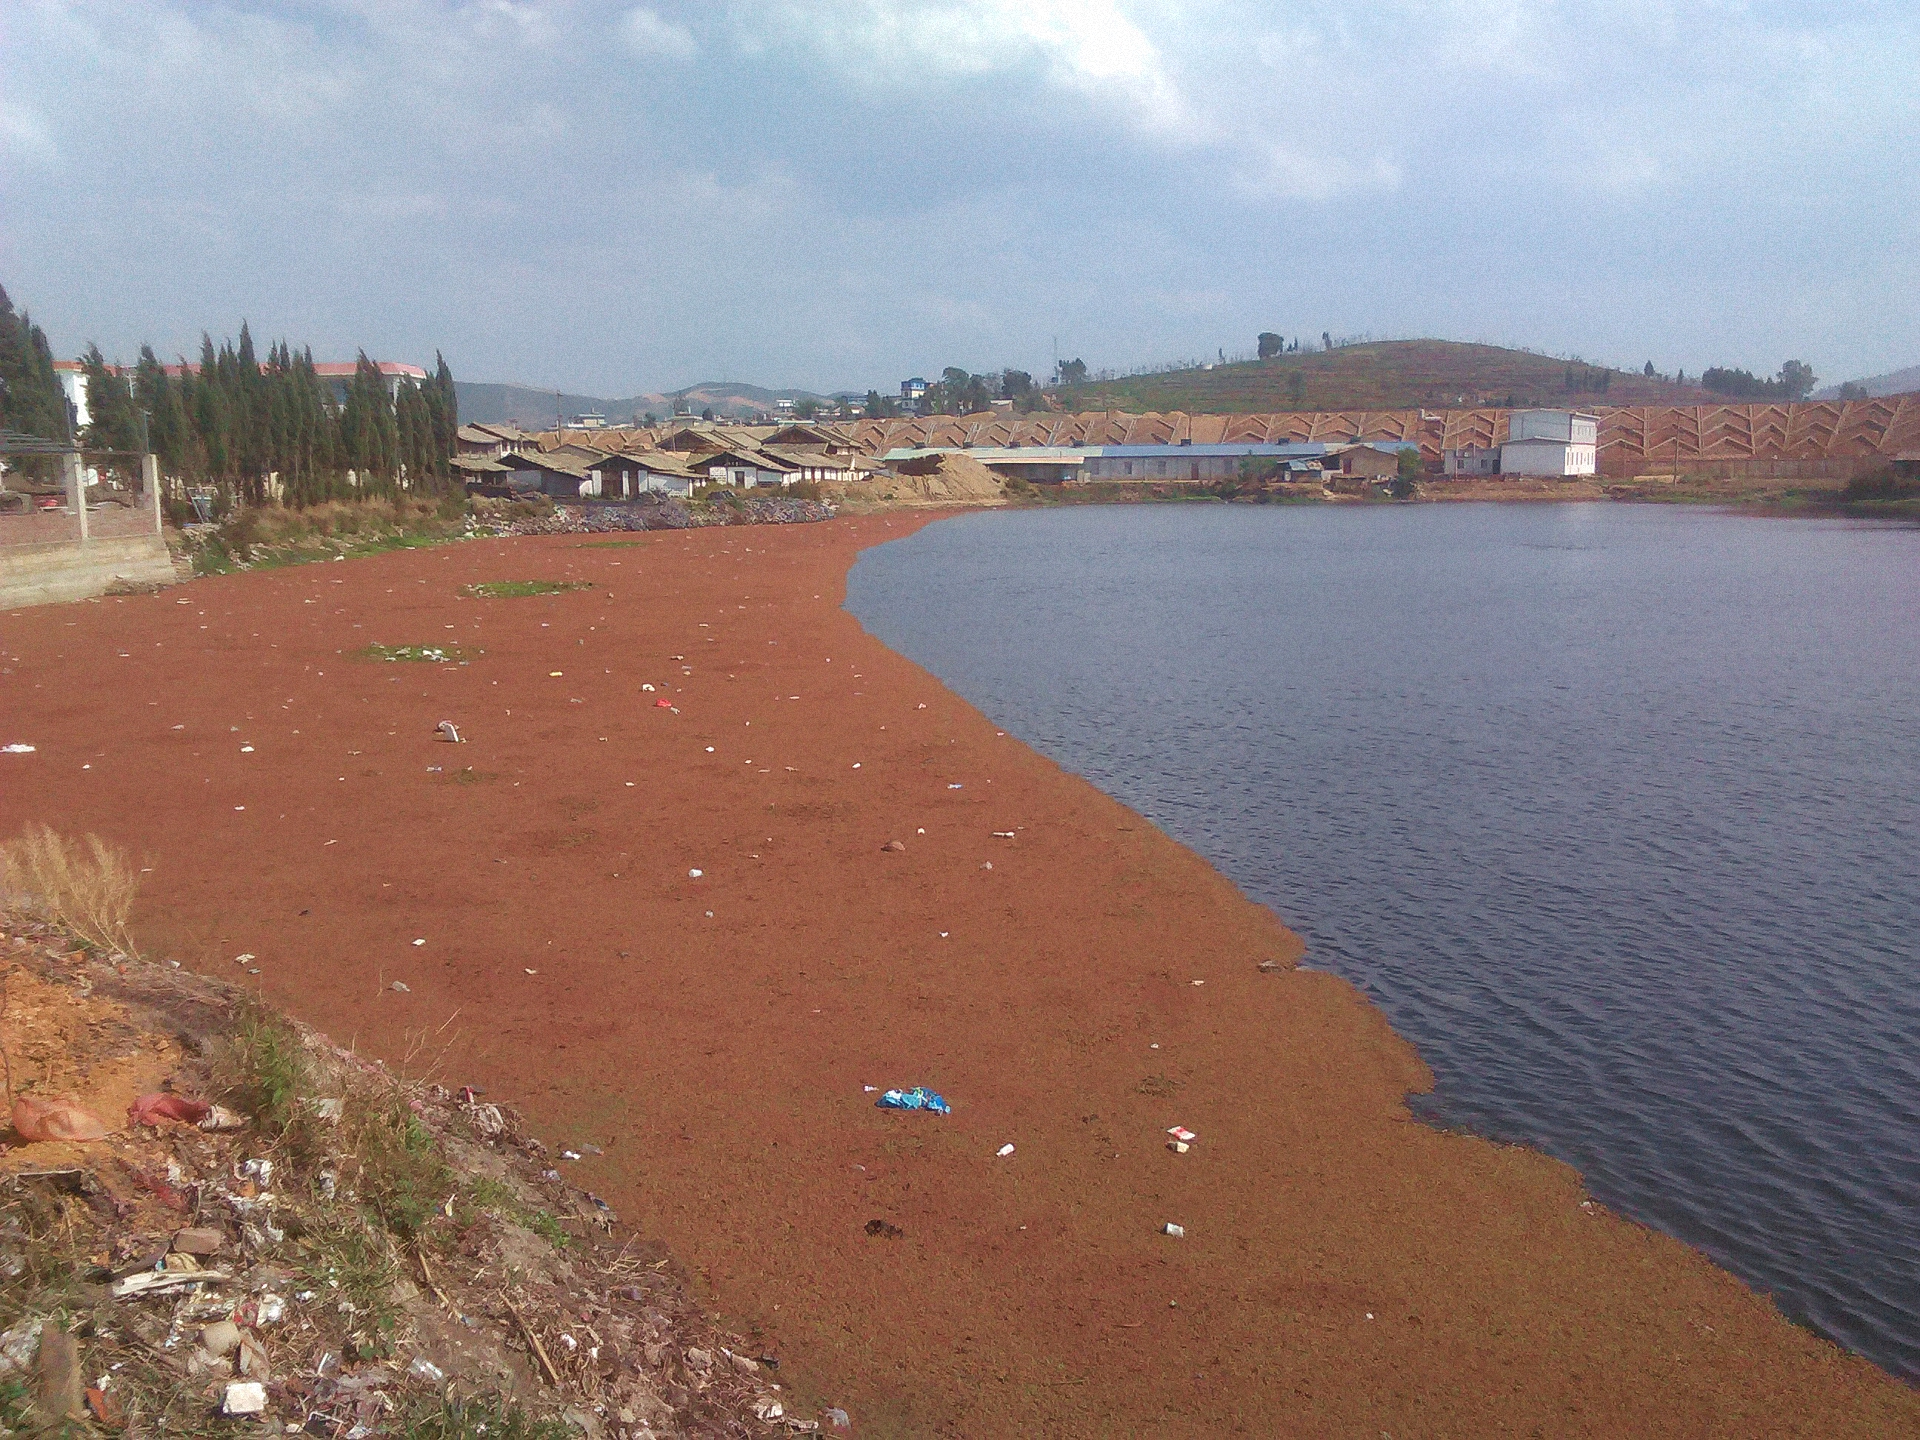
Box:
(0, 0, 1920, 396)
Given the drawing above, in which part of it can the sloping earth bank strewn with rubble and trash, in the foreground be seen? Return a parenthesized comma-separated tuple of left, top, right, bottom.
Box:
(0, 918, 845, 1440)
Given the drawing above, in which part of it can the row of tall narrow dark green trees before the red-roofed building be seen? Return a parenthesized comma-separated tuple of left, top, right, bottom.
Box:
(83, 324, 459, 505)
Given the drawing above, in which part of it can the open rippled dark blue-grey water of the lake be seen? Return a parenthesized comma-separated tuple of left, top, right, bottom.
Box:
(849, 505, 1920, 1379)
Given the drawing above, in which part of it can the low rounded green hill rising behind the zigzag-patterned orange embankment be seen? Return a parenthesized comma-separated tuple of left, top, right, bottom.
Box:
(1048, 340, 1715, 415)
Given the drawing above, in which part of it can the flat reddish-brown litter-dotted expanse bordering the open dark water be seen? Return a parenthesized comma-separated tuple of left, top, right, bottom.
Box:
(0, 516, 1920, 1440)
